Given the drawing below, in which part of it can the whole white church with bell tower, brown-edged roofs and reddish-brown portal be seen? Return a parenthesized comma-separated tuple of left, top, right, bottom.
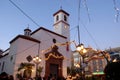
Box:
(0, 9, 71, 80)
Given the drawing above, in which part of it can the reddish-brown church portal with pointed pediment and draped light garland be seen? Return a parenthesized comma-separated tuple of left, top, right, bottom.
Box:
(45, 46, 64, 78)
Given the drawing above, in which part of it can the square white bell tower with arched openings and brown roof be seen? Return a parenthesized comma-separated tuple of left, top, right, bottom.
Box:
(53, 9, 70, 41)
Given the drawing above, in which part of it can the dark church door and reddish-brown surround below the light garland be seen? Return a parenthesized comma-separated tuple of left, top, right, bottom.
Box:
(45, 57, 63, 77)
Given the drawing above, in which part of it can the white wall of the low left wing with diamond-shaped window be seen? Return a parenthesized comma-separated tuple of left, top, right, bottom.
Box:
(10, 38, 39, 77)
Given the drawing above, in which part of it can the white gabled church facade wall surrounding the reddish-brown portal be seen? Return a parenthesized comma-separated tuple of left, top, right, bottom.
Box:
(32, 30, 71, 77)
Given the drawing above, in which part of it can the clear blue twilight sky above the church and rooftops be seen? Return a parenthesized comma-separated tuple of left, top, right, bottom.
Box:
(0, 0, 120, 50)
